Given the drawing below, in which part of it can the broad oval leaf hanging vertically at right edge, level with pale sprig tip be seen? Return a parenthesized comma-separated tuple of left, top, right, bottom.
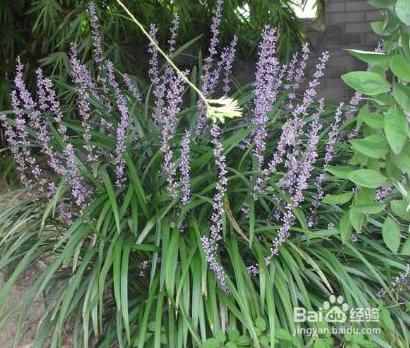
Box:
(384, 108, 409, 155)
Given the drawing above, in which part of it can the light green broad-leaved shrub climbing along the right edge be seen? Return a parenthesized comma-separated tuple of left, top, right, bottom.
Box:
(333, 1, 410, 302)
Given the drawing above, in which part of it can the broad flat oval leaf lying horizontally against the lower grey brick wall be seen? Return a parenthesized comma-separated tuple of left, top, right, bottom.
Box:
(342, 71, 390, 96)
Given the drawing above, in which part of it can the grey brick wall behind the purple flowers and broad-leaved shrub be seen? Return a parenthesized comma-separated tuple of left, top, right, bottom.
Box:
(310, 0, 380, 102)
